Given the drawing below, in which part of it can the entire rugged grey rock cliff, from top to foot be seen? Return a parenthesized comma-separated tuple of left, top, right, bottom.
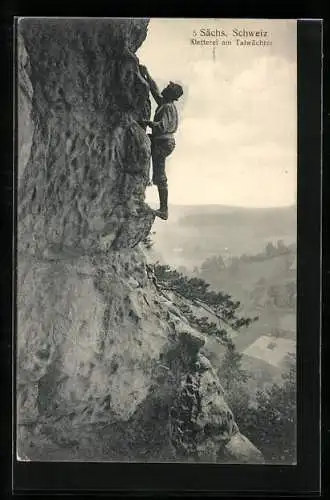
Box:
(17, 19, 263, 462)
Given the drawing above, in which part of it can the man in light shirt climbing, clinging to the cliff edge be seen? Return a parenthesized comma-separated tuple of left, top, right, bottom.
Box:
(140, 65, 183, 220)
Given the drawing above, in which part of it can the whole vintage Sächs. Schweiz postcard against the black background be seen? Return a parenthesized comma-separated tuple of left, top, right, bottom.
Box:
(15, 17, 298, 467)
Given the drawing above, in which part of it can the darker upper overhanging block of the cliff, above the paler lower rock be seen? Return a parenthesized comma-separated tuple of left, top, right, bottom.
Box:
(19, 19, 154, 255)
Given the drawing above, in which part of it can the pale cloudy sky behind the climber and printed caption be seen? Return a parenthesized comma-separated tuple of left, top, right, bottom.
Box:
(137, 19, 297, 207)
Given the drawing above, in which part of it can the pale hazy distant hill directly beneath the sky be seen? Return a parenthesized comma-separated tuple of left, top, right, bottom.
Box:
(153, 205, 296, 269)
